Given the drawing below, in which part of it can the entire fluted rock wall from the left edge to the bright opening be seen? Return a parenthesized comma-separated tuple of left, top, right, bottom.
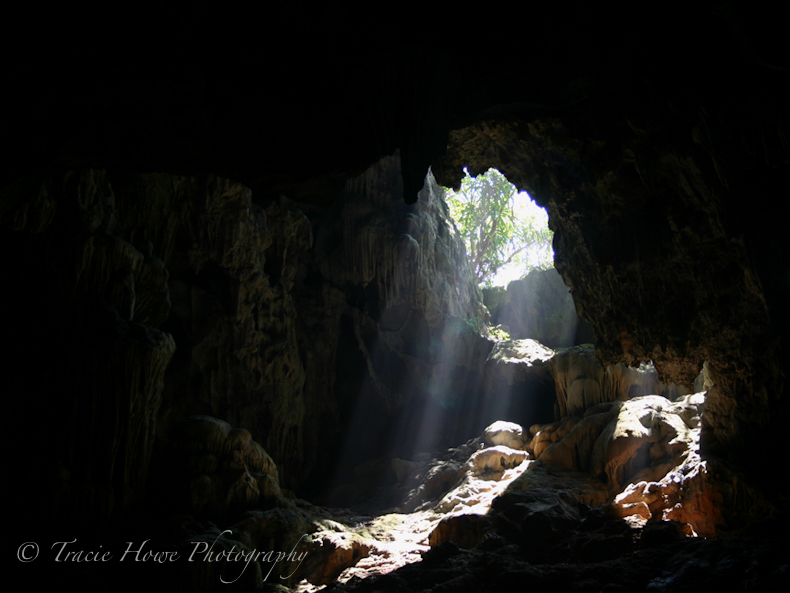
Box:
(2, 150, 490, 516)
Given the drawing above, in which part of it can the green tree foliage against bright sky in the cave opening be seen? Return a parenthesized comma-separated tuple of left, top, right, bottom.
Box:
(445, 169, 554, 286)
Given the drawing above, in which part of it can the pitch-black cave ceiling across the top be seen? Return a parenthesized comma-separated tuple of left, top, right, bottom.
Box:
(9, 3, 786, 201)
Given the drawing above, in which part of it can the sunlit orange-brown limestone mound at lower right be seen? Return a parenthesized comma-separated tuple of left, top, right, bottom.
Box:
(528, 393, 774, 536)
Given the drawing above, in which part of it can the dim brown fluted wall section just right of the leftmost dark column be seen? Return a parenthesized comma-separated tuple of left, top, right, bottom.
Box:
(85, 174, 312, 490)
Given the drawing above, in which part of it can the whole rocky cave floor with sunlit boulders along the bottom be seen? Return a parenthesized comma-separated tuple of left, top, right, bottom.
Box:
(15, 340, 790, 593)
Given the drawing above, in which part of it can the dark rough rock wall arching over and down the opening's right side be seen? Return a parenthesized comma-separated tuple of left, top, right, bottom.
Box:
(434, 115, 784, 462)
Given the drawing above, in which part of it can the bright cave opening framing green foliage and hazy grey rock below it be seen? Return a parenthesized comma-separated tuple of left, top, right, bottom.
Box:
(443, 160, 595, 348)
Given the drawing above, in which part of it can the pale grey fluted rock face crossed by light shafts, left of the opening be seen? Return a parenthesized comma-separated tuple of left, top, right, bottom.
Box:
(294, 154, 491, 490)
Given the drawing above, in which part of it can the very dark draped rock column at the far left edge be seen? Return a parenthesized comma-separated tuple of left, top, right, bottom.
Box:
(2, 170, 176, 517)
